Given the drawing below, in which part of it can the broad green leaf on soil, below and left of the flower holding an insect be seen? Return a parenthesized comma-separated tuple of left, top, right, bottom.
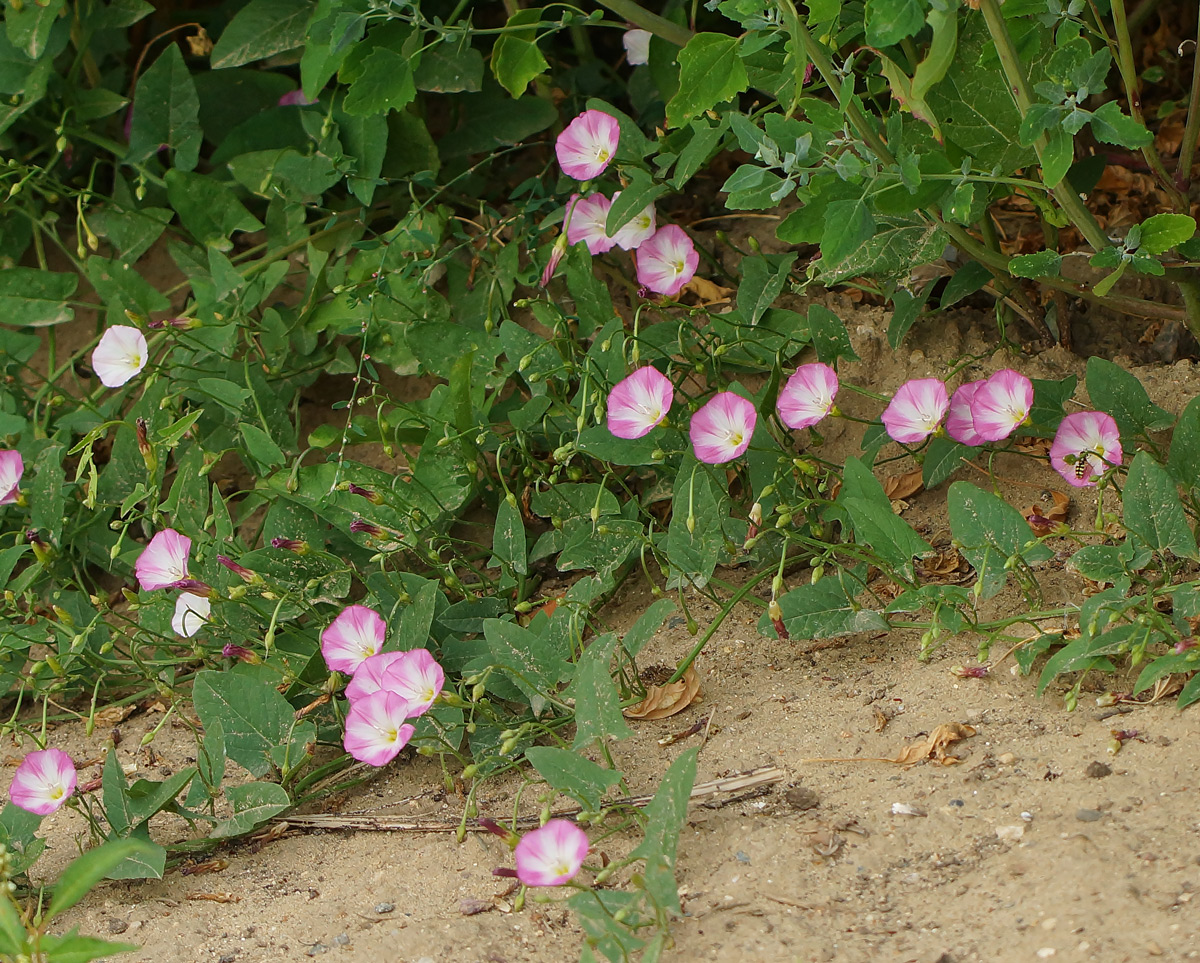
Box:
(949, 482, 1054, 598)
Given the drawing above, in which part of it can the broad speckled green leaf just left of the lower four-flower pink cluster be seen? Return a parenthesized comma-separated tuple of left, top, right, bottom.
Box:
(192, 670, 295, 776)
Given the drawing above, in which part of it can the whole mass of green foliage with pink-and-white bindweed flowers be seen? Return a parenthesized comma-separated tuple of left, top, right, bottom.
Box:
(7, 0, 1200, 961)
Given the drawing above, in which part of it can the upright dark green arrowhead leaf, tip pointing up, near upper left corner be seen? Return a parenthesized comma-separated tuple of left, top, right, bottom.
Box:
(125, 43, 203, 171)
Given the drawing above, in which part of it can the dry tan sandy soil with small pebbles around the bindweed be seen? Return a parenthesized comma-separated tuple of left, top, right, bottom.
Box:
(16, 312, 1200, 963)
